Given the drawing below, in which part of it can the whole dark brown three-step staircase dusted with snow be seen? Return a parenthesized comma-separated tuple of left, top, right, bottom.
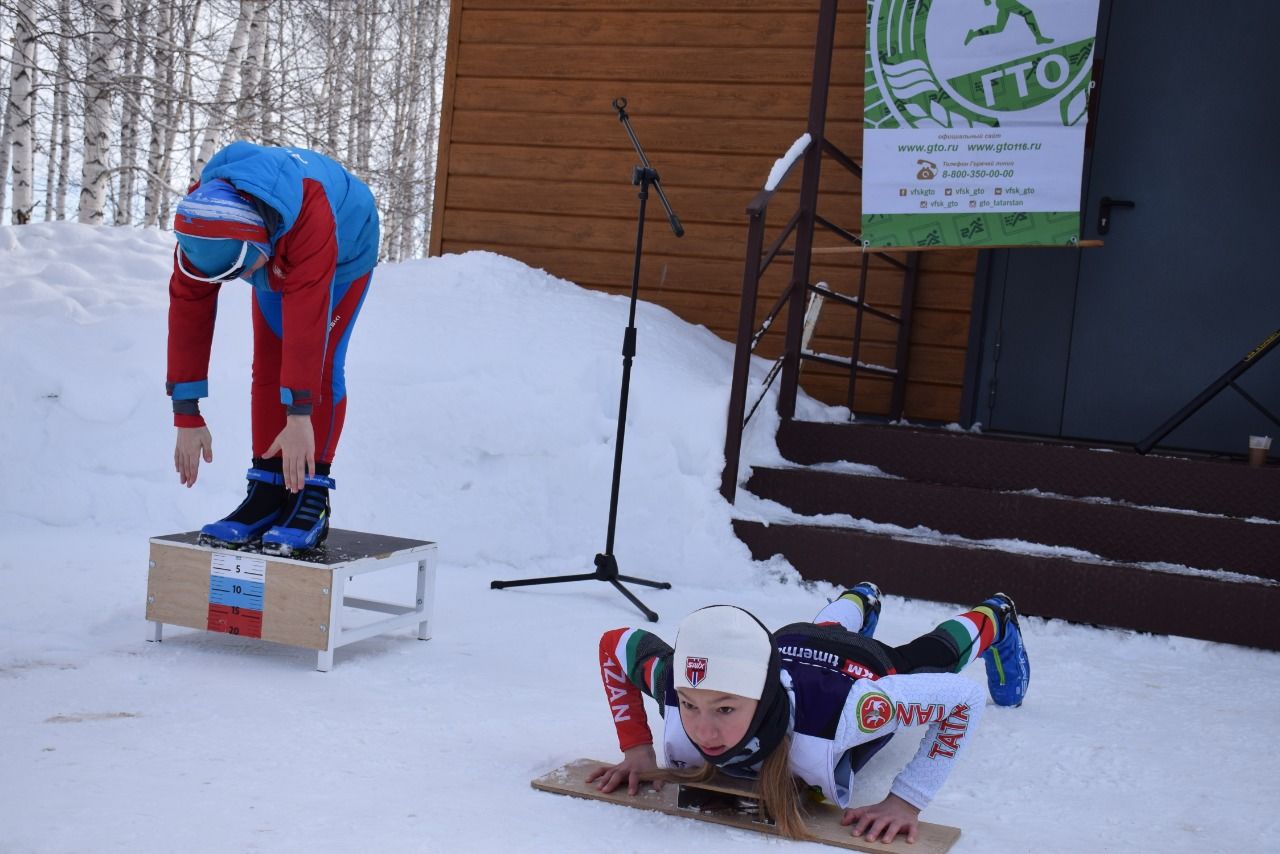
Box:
(735, 421, 1280, 649)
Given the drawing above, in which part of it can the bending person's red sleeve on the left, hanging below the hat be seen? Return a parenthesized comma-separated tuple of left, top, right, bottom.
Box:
(165, 247, 220, 426)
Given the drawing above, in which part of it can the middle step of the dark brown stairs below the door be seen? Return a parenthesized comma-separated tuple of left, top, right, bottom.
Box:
(746, 467, 1280, 580)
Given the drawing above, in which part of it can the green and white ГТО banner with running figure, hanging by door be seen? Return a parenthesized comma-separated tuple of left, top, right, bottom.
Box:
(863, 0, 1098, 246)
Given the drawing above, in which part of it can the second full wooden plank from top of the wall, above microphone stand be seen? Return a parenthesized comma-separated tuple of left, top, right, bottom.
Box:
(458, 42, 865, 86)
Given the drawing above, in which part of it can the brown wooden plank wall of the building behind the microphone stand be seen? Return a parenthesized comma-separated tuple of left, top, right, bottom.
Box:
(431, 0, 975, 421)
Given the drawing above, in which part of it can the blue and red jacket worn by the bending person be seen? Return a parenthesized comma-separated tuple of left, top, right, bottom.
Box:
(166, 142, 379, 426)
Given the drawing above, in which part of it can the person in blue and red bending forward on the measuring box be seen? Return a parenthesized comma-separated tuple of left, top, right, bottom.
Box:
(166, 142, 379, 554)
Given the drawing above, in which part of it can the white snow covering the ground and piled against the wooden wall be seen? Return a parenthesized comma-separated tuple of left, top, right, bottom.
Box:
(0, 224, 1280, 854)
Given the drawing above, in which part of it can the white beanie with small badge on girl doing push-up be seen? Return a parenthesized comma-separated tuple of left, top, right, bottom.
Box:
(675, 604, 773, 700)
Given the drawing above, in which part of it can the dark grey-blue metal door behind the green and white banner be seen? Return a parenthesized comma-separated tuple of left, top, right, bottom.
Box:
(969, 0, 1280, 453)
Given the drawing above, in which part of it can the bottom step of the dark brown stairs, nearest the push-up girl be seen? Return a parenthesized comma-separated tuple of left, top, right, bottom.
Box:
(733, 520, 1280, 656)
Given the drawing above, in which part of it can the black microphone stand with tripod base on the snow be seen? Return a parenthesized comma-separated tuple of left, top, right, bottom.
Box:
(489, 97, 685, 622)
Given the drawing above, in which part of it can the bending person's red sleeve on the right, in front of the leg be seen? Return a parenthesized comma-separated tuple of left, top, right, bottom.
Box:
(268, 178, 338, 407)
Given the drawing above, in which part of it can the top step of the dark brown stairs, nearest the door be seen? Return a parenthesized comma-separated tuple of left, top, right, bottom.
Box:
(778, 421, 1280, 521)
